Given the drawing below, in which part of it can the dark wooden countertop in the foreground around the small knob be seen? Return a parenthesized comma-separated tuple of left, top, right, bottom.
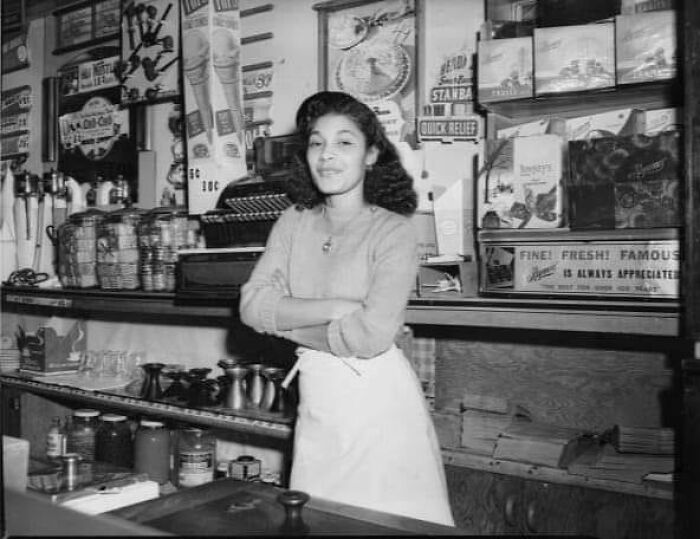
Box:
(109, 479, 470, 537)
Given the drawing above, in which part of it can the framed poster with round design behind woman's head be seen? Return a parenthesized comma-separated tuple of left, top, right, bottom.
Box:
(314, 0, 421, 145)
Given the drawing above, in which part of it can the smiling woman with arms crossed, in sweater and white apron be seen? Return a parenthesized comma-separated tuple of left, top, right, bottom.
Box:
(240, 92, 454, 525)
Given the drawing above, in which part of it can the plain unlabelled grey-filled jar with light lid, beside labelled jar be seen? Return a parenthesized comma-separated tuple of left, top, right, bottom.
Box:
(134, 419, 170, 484)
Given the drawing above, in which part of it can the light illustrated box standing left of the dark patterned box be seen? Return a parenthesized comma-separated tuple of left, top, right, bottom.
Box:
(477, 135, 564, 228)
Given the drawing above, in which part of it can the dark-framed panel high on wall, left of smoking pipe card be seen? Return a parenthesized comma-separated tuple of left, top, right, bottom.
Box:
(53, 0, 121, 54)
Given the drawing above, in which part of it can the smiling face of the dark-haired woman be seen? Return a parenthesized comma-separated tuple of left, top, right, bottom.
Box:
(306, 114, 377, 202)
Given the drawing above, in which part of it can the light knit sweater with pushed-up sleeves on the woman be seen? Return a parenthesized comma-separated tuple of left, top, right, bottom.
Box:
(240, 202, 418, 358)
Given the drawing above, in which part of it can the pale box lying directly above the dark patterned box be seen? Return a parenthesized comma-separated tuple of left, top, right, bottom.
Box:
(566, 109, 644, 141)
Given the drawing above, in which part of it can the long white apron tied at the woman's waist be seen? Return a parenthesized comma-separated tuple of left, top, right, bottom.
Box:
(290, 346, 454, 526)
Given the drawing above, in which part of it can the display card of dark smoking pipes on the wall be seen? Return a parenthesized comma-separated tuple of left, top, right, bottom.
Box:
(118, 0, 180, 104)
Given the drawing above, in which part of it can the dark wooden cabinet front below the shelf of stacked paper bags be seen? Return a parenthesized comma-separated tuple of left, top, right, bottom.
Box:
(446, 466, 680, 539)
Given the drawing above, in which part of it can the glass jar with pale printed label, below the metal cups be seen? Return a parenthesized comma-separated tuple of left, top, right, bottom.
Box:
(177, 429, 216, 487)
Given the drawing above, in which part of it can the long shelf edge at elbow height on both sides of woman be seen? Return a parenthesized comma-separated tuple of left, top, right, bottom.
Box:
(2, 287, 681, 337)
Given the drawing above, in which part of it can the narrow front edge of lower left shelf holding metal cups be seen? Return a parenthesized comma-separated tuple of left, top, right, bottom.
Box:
(0, 373, 294, 439)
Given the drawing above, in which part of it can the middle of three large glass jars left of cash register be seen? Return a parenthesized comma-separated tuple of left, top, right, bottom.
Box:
(97, 208, 145, 290)
